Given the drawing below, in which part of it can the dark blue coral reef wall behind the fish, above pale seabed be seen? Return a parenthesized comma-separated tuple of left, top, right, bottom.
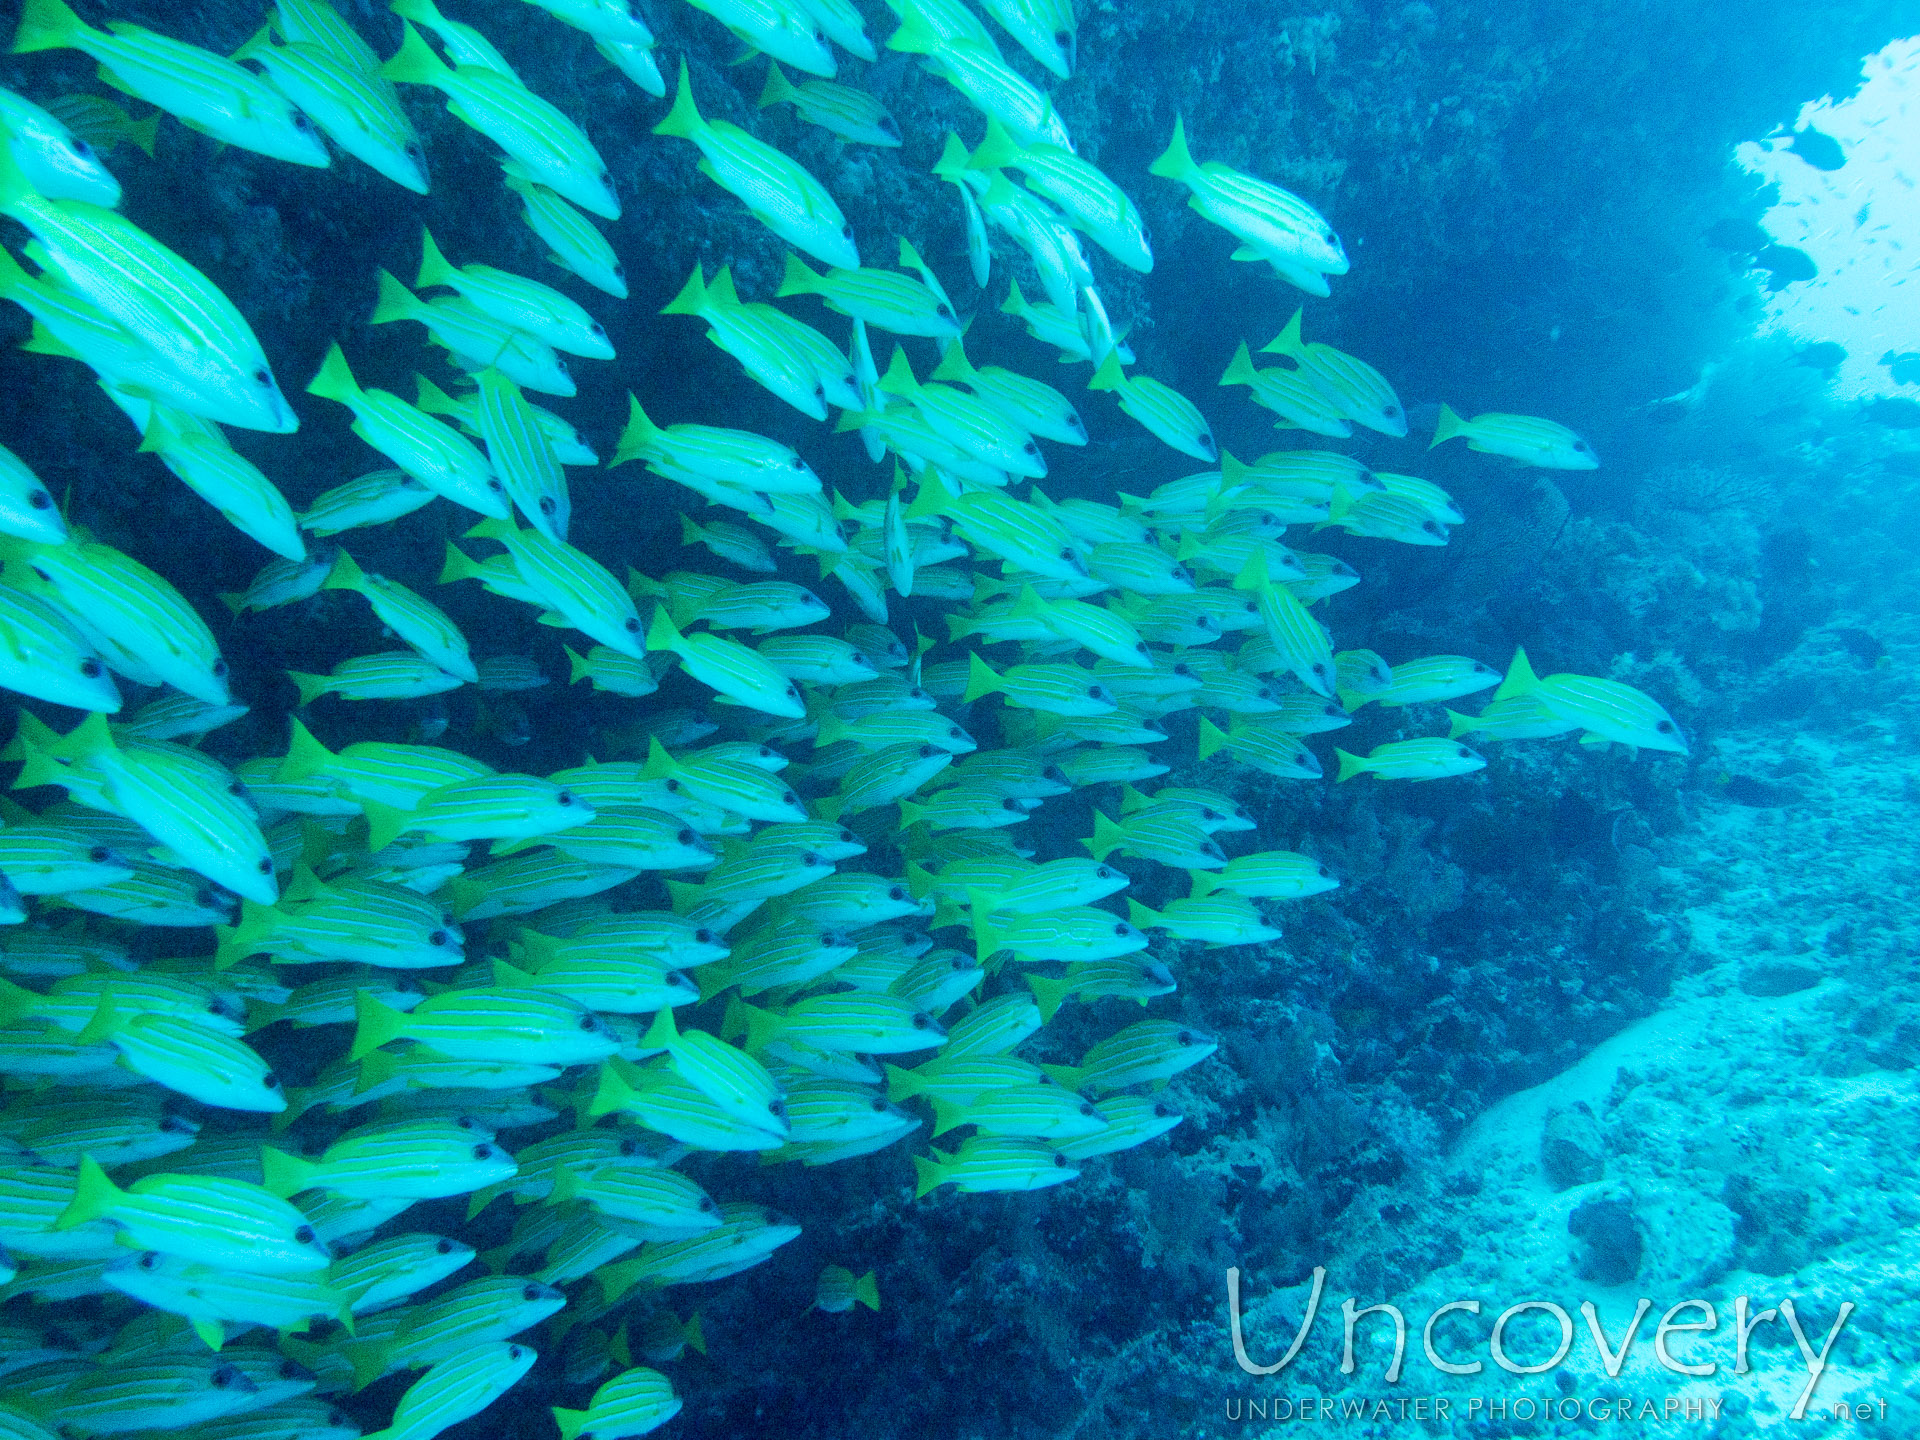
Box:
(0, 0, 1920, 1440)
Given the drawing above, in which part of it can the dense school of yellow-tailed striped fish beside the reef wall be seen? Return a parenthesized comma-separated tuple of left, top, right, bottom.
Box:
(0, 0, 1686, 1440)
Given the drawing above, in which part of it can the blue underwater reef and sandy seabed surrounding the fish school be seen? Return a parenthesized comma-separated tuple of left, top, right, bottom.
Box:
(0, 0, 1920, 1440)
